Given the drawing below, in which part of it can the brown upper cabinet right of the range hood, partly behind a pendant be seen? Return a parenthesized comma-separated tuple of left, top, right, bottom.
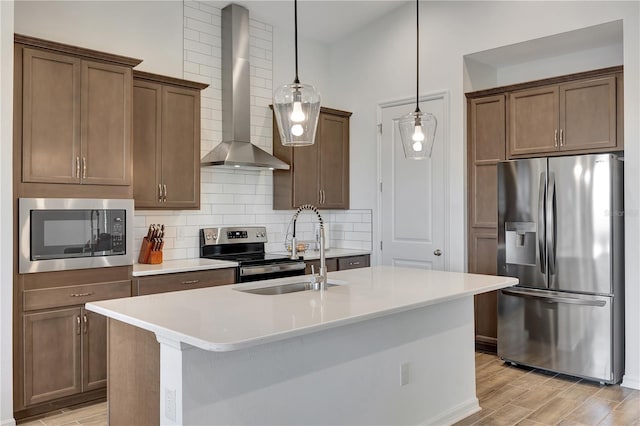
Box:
(273, 107, 351, 210)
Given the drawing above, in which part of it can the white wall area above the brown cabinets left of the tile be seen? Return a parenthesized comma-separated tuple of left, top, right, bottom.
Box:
(15, 0, 183, 78)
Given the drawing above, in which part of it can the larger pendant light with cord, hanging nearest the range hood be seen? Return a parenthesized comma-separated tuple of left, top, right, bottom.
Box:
(273, 0, 320, 146)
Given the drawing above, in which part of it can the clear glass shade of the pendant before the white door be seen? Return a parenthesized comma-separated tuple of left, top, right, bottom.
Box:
(398, 110, 438, 160)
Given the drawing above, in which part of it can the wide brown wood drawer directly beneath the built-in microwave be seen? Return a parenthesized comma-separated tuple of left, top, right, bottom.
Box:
(23, 280, 131, 311)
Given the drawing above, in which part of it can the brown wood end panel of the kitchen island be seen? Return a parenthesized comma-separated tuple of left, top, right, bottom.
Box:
(107, 318, 160, 426)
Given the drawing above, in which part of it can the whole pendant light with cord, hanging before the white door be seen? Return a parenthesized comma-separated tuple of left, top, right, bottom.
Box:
(398, 0, 437, 160)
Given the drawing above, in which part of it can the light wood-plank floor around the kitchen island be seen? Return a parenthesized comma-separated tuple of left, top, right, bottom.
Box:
(18, 353, 640, 426)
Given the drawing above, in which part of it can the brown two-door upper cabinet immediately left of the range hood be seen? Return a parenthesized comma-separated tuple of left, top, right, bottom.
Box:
(133, 71, 207, 209)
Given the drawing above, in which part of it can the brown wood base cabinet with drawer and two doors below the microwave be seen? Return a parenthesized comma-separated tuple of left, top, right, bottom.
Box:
(14, 267, 131, 419)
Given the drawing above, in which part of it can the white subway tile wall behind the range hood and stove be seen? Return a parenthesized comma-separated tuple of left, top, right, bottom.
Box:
(134, 1, 372, 260)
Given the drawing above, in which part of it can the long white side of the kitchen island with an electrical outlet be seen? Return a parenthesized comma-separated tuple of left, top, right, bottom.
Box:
(160, 297, 480, 425)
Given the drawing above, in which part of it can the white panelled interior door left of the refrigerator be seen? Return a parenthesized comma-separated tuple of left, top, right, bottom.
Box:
(380, 94, 448, 270)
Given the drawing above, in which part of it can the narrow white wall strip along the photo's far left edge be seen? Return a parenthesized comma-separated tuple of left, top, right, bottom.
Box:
(0, 1, 15, 426)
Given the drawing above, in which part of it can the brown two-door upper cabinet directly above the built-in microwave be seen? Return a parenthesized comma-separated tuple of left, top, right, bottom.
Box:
(16, 41, 139, 185)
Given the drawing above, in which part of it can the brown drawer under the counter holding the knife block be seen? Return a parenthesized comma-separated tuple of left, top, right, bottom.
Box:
(133, 268, 236, 296)
